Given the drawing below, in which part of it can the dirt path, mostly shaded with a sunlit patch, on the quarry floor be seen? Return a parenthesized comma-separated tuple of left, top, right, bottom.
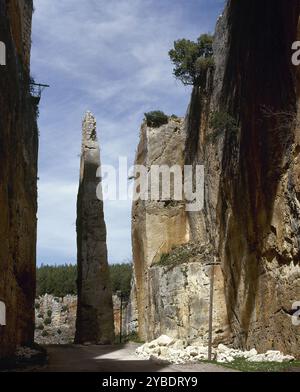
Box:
(34, 344, 237, 372)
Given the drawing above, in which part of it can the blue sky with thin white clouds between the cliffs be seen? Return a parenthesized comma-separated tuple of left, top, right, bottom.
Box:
(32, 0, 224, 264)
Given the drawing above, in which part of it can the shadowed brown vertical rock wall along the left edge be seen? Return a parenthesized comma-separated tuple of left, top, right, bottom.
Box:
(0, 0, 38, 358)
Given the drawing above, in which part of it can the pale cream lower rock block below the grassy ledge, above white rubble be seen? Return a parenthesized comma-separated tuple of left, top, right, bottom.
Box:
(148, 260, 229, 345)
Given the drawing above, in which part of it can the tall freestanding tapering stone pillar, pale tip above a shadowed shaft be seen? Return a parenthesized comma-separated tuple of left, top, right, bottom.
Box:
(75, 112, 114, 344)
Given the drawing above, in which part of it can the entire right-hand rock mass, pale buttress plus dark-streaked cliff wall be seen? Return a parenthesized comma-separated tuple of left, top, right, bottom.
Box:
(132, 0, 300, 357)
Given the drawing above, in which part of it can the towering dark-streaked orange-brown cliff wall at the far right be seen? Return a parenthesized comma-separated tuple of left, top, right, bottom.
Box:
(217, 0, 300, 356)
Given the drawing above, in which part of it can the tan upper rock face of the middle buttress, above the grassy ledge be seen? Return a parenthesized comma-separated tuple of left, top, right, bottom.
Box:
(132, 118, 189, 339)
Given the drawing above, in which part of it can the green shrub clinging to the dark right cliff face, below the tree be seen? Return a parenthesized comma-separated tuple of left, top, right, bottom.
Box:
(208, 111, 238, 142)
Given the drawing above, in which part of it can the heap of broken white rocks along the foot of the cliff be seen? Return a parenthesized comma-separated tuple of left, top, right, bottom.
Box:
(136, 335, 295, 365)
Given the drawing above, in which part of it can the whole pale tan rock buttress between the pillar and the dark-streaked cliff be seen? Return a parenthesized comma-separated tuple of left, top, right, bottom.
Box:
(132, 113, 230, 344)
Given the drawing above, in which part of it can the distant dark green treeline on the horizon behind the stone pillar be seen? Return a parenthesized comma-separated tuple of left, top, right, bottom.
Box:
(36, 264, 132, 299)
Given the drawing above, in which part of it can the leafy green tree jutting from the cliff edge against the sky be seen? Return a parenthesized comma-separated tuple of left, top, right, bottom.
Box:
(169, 34, 214, 86)
